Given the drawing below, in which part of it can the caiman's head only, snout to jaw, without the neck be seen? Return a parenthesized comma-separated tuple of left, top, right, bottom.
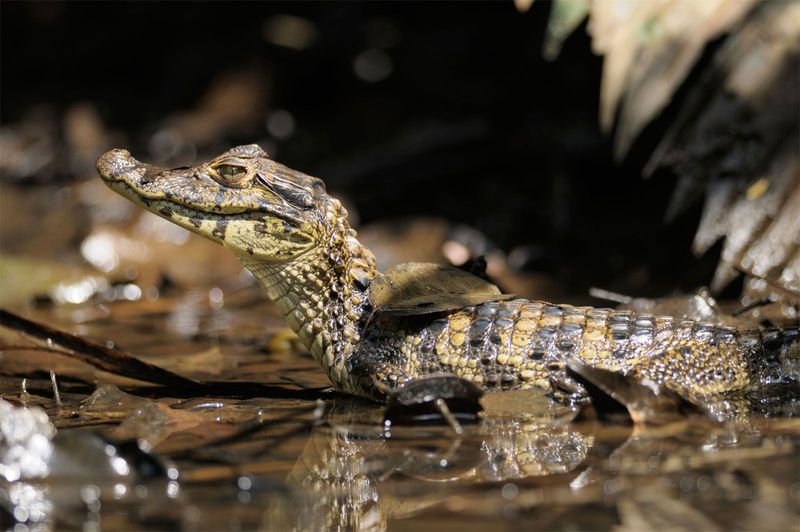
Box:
(97, 144, 332, 263)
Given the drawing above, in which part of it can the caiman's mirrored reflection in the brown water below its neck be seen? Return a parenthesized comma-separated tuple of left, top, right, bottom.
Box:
(264, 401, 593, 530)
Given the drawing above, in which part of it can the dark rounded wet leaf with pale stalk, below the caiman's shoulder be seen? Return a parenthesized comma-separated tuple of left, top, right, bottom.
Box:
(384, 374, 483, 434)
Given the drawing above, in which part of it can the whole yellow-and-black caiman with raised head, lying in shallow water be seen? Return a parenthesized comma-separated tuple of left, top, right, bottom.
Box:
(97, 145, 800, 414)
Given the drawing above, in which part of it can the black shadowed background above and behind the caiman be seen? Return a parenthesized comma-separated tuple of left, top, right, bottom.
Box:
(0, 2, 720, 295)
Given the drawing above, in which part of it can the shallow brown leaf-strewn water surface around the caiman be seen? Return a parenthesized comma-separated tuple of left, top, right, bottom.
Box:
(0, 287, 800, 530)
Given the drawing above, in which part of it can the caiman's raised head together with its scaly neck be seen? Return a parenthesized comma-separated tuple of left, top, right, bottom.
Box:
(97, 144, 378, 394)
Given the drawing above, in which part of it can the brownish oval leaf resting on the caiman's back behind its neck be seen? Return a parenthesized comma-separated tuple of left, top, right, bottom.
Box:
(369, 262, 514, 316)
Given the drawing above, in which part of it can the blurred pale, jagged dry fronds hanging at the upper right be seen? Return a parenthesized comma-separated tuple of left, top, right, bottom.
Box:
(532, 0, 800, 301)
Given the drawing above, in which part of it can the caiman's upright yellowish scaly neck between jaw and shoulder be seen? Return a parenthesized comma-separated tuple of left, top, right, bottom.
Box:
(239, 200, 378, 390)
